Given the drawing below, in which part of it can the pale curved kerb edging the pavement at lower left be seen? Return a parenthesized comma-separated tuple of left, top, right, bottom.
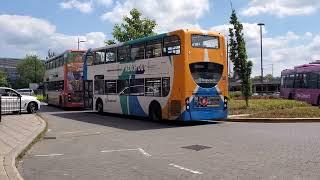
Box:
(4, 115, 47, 180)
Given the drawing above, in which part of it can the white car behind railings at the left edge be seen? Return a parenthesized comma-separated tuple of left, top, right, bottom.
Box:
(0, 87, 40, 113)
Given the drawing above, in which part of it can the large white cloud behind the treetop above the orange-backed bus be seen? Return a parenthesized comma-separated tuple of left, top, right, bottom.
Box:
(101, 0, 209, 32)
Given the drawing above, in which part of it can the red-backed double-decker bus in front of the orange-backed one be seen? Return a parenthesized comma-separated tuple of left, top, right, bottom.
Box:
(44, 50, 86, 108)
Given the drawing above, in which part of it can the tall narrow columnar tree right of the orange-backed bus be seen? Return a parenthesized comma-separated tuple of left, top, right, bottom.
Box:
(229, 10, 253, 107)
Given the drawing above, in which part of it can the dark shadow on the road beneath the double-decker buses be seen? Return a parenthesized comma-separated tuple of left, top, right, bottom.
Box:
(41, 106, 221, 131)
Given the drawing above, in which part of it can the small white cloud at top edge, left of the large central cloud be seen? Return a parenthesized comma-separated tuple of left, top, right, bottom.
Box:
(60, 0, 92, 13)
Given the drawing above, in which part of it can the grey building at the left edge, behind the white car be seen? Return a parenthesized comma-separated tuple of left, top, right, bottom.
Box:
(0, 58, 21, 83)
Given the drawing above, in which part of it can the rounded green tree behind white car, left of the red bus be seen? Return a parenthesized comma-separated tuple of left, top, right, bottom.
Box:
(15, 55, 45, 88)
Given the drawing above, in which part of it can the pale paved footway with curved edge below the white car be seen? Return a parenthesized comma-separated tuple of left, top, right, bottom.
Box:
(0, 114, 46, 180)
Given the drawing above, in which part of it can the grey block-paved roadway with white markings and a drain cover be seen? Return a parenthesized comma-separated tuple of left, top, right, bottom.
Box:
(19, 107, 320, 180)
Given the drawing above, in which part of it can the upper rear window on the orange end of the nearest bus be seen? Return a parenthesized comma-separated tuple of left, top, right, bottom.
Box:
(191, 34, 219, 49)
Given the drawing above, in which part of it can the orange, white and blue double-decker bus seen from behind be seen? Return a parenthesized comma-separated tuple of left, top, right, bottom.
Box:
(84, 30, 228, 121)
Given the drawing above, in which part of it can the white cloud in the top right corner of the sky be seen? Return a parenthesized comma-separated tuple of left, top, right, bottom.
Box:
(241, 0, 320, 17)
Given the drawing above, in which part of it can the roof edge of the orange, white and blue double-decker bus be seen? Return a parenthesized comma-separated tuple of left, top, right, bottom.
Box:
(92, 29, 224, 51)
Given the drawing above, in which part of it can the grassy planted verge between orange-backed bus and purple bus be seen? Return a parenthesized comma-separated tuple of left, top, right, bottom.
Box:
(229, 99, 320, 118)
